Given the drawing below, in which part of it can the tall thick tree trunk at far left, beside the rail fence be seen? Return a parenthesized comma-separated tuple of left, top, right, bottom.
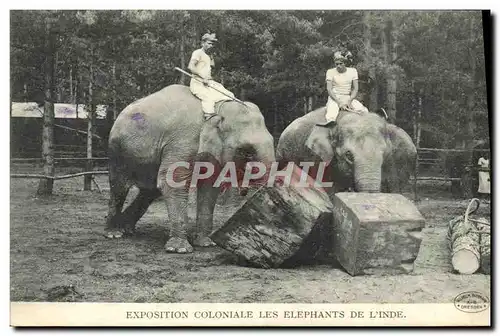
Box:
(37, 21, 56, 195)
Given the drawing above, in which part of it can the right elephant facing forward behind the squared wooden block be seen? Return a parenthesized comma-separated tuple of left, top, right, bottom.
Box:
(276, 107, 417, 193)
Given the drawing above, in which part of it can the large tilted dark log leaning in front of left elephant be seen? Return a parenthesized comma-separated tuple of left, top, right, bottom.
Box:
(211, 166, 333, 268)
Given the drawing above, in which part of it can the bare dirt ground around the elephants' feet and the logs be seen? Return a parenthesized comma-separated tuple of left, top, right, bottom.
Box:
(10, 167, 490, 303)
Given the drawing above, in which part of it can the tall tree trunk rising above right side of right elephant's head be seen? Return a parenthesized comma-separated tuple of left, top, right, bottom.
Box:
(385, 18, 397, 122)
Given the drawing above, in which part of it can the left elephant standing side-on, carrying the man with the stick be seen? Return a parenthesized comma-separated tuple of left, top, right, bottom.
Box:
(105, 84, 275, 253)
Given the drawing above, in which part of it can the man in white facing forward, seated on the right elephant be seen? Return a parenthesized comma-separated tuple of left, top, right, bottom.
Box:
(318, 51, 368, 126)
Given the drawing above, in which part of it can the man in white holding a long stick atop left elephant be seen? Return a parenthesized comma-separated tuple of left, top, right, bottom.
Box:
(188, 33, 234, 119)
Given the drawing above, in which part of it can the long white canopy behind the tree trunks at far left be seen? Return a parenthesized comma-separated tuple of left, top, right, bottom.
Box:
(12, 102, 108, 119)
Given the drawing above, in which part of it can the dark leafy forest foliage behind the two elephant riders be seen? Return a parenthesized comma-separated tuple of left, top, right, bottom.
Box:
(11, 10, 489, 147)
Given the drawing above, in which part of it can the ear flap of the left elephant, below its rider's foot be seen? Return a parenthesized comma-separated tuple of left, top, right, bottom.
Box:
(197, 115, 223, 163)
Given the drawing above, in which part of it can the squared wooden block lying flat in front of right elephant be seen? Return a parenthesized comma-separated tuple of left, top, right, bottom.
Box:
(332, 193, 425, 276)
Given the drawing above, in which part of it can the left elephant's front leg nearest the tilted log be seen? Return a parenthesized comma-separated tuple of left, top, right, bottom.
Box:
(194, 185, 220, 247)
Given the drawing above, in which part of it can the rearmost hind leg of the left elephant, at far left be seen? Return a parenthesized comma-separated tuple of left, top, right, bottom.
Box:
(105, 169, 130, 238)
